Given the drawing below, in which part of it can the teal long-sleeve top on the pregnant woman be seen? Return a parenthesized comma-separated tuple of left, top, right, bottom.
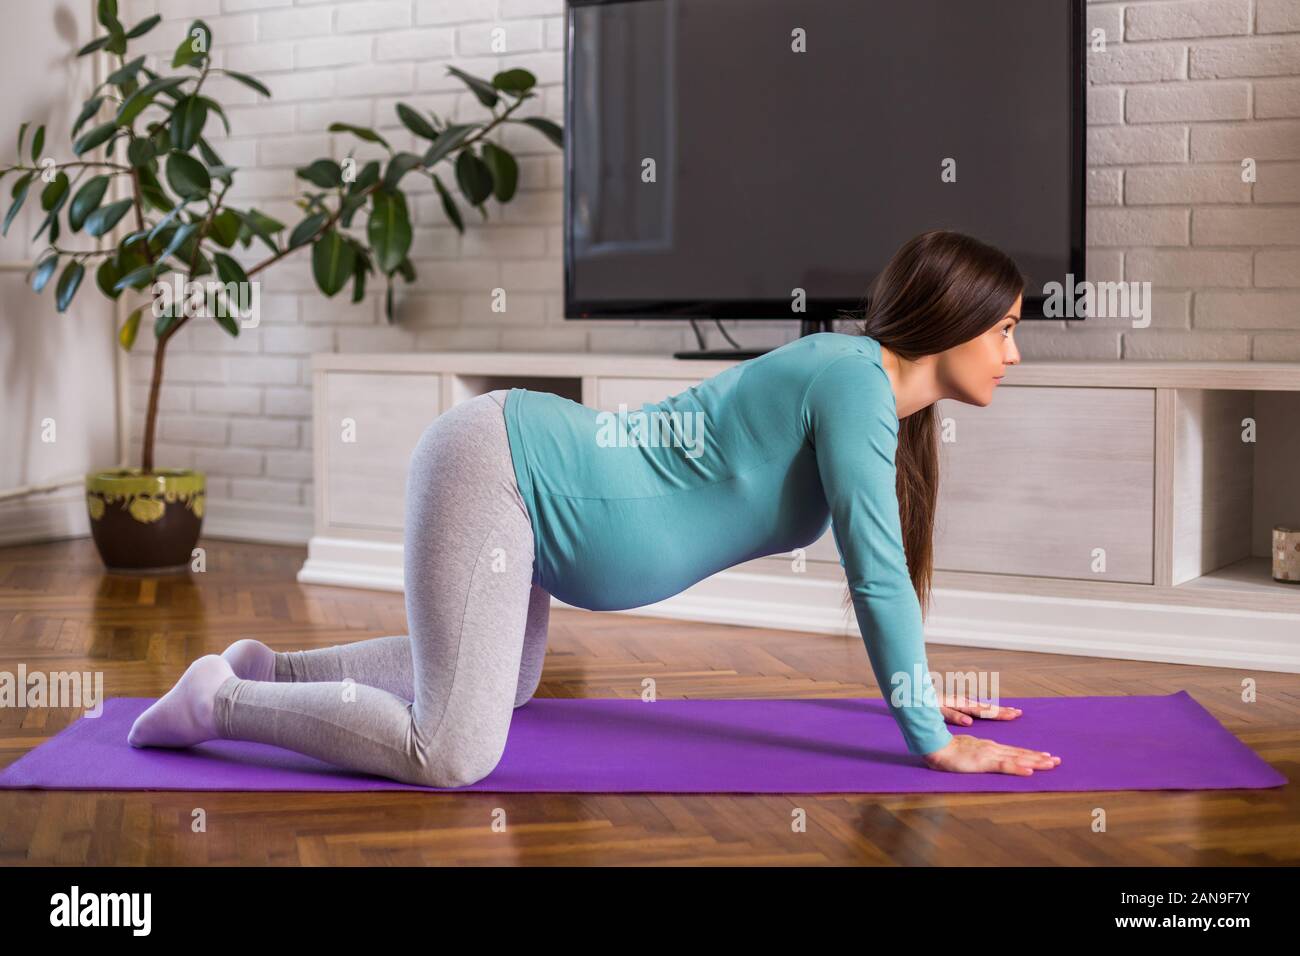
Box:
(504, 332, 952, 753)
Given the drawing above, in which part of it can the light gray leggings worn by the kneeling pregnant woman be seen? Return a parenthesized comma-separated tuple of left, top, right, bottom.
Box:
(216, 389, 550, 787)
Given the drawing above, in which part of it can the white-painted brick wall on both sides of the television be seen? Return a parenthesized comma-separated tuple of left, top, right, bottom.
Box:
(114, 0, 1300, 522)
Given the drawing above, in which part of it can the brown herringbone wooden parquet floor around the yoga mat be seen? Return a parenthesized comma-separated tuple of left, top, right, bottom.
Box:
(0, 538, 1300, 866)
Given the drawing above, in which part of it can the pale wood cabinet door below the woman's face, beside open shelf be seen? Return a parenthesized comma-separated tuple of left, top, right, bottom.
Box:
(935, 385, 1156, 584)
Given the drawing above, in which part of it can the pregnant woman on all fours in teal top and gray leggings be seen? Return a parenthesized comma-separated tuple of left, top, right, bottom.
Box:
(129, 232, 1060, 787)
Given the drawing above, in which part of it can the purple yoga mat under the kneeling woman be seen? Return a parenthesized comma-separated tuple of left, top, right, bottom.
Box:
(0, 691, 1286, 793)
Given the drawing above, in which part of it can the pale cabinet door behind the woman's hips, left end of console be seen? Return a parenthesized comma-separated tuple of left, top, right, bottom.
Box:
(319, 372, 441, 532)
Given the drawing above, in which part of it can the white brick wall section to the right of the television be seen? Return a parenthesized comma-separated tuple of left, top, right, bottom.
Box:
(1081, 0, 1300, 362)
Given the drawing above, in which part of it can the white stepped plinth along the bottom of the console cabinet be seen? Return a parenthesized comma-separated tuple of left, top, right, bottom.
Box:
(298, 537, 1300, 674)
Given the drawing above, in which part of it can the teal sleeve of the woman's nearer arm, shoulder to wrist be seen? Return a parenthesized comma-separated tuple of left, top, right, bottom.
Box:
(803, 354, 953, 754)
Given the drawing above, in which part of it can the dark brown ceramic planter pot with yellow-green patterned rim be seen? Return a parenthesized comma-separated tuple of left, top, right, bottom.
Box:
(86, 468, 207, 572)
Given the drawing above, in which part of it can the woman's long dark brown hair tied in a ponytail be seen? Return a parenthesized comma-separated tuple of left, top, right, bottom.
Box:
(844, 229, 1026, 618)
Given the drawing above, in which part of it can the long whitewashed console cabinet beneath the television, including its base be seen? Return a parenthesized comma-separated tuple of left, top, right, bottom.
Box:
(299, 351, 1300, 672)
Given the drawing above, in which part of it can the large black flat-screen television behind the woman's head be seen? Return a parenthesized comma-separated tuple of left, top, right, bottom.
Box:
(564, 0, 1086, 320)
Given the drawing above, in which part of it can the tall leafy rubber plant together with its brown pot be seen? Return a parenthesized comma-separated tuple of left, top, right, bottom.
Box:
(0, 0, 563, 571)
